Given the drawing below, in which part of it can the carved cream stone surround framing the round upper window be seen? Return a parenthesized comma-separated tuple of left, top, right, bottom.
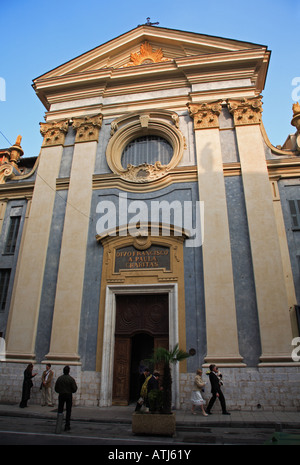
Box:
(106, 110, 185, 183)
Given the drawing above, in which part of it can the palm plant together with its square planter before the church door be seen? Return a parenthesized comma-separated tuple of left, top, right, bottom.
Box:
(132, 344, 189, 436)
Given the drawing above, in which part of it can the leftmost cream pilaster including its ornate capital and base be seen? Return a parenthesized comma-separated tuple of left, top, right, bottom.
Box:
(6, 120, 68, 361)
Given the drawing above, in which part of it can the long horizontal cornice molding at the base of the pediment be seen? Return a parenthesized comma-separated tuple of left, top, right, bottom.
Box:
(33, 47, 269, 110)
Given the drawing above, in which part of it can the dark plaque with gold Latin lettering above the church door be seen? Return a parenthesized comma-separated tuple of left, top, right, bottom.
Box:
(115, 245, 170, 272)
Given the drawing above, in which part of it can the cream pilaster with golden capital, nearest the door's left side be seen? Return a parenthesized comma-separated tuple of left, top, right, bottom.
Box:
(46, 115, 102, 364)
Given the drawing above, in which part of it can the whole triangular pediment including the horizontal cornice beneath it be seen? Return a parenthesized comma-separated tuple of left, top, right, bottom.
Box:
(33, 26, 270, 109)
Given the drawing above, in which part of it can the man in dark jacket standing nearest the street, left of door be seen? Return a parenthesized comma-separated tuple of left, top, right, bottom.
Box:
(55, 366, 77, 431)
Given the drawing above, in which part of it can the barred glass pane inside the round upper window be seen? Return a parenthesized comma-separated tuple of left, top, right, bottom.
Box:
(121, 135, 173, 169)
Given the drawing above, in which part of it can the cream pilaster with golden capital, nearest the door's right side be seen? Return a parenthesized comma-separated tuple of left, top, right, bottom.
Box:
(189, 102, 242, 366)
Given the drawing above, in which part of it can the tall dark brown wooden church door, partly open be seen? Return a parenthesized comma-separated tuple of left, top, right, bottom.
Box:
(112, 294, 169, 405)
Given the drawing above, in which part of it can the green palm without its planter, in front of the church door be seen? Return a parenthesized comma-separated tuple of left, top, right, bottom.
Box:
(152, 344, 189, 413)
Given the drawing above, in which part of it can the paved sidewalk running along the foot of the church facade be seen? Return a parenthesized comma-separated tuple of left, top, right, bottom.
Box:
(0, 404, 300, 431)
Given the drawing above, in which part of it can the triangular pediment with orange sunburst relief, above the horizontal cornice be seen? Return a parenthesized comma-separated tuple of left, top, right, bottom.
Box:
(37, 25, 266, 79)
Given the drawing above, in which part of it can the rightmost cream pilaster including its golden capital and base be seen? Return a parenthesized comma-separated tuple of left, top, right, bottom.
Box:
(228, 97, 292, 364)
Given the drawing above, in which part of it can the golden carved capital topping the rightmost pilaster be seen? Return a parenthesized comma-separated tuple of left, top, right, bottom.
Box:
(227, 95, 262, 126)
